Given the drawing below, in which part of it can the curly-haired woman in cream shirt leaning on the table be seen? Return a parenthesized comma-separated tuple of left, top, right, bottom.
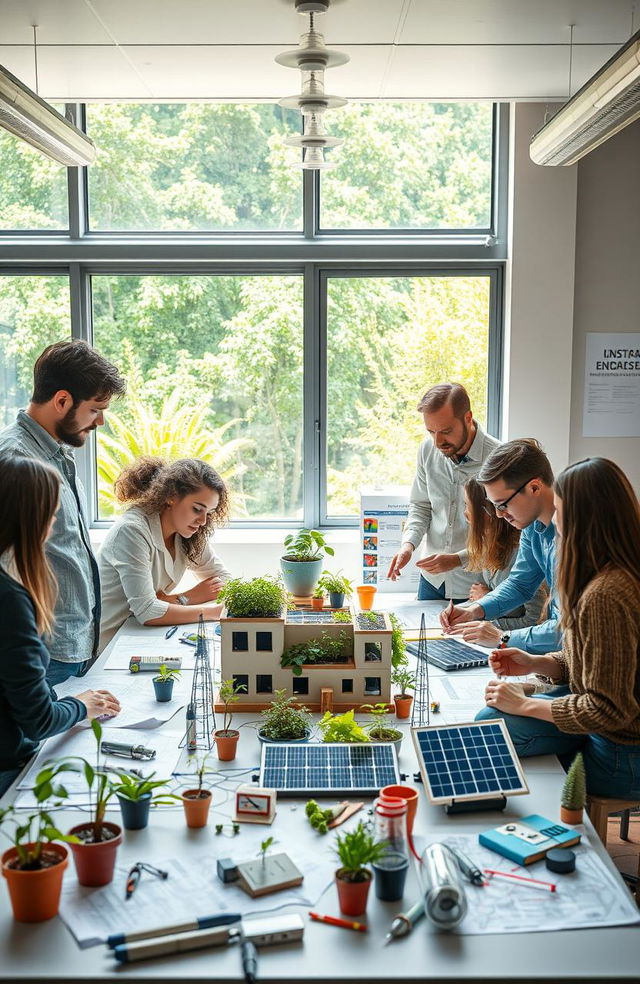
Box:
(99, 458, 230, 650)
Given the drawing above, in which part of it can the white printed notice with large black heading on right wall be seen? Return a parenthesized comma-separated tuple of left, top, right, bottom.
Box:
(582, 331, 640, 437)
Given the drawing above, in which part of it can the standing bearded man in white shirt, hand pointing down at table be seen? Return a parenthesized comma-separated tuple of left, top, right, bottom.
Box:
(387, 383, 500, 601)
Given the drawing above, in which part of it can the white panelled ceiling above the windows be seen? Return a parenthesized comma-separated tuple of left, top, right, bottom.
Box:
(0, 0, 640, 101)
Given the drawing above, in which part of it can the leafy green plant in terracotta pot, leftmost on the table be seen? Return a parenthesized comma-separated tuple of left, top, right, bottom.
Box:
(0, 763, 77, 923)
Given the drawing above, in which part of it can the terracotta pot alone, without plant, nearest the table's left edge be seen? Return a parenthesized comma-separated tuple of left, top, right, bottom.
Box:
(0, 844, 69, 922)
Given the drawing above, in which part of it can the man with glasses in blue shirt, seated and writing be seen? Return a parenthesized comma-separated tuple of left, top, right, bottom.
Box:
(440, 439, 561, 653)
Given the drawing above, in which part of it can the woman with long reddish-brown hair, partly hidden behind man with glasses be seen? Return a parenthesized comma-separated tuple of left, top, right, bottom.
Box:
(464, 478, 547, 632)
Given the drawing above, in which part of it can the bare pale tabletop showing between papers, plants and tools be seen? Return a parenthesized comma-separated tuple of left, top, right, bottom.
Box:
(0, 596, 640, 984)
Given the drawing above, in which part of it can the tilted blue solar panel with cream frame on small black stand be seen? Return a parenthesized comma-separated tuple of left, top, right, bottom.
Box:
(412, 720, 529, 813)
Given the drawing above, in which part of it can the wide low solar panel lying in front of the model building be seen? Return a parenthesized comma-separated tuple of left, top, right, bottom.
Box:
(259, 742, 400, 796)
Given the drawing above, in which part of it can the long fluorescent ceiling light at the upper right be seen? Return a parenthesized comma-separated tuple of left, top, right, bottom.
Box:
(529, 31, 640, 165)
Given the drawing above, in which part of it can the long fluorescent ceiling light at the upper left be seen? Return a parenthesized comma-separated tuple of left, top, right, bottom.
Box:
(0, 65, 96, 167)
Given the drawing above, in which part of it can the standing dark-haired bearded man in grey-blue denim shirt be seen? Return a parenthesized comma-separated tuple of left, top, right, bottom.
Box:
(0, 339, 125, 686)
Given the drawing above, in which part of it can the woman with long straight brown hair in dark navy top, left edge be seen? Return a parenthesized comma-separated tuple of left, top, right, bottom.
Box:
(0, 455, 120, 795)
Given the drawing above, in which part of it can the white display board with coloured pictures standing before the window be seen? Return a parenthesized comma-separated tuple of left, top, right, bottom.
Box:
(360, 485, 418, 592)
